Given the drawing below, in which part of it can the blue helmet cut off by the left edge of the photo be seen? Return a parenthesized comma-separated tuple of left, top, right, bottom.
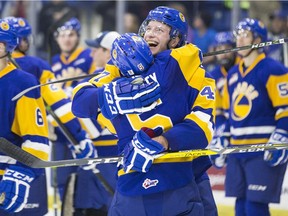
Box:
(0, 19, 18, 53)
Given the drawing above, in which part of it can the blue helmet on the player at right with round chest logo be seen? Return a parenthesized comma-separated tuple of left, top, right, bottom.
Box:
(233, 18, 268, 42)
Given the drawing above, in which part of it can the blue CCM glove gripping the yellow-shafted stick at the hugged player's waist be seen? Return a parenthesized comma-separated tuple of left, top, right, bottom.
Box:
(123, 128, 165, 173)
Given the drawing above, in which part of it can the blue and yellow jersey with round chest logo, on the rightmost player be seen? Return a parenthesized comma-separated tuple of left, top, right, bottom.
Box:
(223, 53, 288, 145)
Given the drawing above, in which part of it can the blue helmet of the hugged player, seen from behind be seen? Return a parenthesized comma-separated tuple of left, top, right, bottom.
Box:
(111, 33, 154, 77)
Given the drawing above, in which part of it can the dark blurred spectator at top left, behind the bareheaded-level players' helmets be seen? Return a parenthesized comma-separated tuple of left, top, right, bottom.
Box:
(38, 0, 78, 59)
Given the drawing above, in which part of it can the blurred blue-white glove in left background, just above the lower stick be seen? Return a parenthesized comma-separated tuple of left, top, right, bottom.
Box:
(68, 139, 98, 159)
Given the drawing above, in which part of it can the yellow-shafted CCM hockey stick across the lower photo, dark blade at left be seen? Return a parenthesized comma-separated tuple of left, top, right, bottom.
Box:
(0, 137, 288, 168)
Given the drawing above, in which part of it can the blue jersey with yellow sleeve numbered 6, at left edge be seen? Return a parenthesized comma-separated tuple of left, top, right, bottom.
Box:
(0, 63, 50, 175)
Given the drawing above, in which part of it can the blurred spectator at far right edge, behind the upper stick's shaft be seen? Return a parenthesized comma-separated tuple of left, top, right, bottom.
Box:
(267, 10, 287, 63)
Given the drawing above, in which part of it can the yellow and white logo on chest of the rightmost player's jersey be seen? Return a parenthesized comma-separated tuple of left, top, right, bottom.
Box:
(231, 82, 259, 121)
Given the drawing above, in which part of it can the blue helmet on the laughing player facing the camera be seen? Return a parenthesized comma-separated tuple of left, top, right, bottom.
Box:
(139, 6, 188, 47)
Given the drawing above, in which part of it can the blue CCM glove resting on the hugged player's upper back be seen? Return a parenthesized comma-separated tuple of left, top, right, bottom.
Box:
(98, 76, 160, 119)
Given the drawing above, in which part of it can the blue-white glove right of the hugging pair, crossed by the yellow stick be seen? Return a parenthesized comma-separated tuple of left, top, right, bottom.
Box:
(210, 136, 229, 169)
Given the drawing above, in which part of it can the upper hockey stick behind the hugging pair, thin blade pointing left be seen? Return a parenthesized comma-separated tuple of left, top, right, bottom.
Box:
(12, 38, 288, 101)
